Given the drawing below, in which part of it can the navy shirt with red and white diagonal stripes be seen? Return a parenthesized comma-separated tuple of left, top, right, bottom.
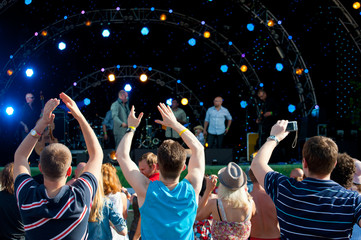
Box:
(15, 172, 97, 240)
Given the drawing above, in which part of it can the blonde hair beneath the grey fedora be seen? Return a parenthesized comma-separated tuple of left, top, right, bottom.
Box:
(218, 183, 252, 208)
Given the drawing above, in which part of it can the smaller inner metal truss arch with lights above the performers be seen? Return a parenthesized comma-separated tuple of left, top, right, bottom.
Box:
(65, 65, 206, 121)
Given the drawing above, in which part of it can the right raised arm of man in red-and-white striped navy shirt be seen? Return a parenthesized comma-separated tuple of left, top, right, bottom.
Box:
(60, 93, 103, 179)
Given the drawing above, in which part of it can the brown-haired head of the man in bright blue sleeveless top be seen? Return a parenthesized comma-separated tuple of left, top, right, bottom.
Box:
(157, 139, 187, 179)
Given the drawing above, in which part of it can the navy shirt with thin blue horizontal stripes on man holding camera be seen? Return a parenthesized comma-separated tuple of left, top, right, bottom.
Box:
(265, 171, 361, 240)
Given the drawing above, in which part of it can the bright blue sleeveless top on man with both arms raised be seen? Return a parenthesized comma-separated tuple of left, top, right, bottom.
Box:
(139, 179, 198, 240)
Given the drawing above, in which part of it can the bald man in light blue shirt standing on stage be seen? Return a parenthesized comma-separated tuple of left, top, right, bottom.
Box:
(203, 97, 232, 148)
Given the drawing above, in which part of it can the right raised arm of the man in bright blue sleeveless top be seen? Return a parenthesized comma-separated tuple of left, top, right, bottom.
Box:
(155, 103, 205, 195)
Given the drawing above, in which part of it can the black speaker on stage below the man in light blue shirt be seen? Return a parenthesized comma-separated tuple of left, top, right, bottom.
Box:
(206, 148, 233, 165)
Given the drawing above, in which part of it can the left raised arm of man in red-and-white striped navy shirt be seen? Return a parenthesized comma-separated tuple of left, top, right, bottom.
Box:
(14, 98, 60, 180)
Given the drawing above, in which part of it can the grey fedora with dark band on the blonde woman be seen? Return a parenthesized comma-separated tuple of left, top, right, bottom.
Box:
(218, 162, 247, 190)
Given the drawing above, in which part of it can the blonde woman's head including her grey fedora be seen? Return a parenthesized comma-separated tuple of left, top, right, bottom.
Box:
(218, 162, 249, 208)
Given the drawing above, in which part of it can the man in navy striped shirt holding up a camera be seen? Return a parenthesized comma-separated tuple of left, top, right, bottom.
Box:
(251, 120, 361, 240)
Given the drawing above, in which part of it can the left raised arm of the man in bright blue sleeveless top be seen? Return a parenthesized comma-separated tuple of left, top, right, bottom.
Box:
(116, 106, 149, 200)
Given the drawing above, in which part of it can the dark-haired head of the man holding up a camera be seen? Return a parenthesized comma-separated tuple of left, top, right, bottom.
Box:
(302, 136, 338, 177)
